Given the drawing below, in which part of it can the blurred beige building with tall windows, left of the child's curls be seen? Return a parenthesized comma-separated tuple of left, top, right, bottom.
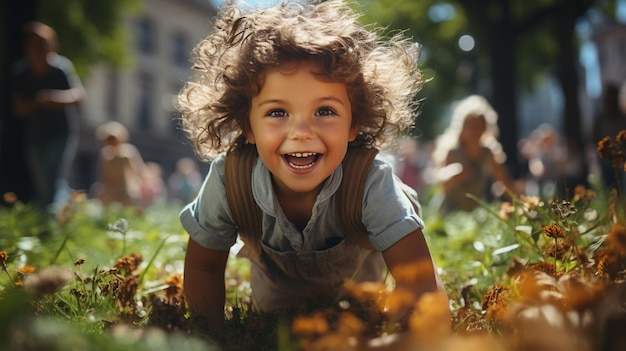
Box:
(71, 0, 216, 194)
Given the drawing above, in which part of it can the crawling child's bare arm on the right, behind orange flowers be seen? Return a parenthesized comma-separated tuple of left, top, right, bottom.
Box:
(383, 229, 448, 308)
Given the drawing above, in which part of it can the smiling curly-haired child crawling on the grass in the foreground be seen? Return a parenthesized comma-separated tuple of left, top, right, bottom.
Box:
(179, 1, 447, 323)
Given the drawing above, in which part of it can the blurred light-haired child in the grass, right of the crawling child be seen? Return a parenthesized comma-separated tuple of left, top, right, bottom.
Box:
(432, 95, 515, 212)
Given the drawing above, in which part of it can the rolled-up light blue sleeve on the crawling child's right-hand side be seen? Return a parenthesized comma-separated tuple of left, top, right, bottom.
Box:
(362, 161, 424, 251)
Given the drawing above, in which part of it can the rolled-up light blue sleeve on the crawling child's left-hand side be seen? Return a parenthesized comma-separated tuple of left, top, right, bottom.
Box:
(179, 155, 237, 251)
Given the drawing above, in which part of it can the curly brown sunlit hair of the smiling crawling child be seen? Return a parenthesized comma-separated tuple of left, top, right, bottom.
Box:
(178, 0, 423, 160)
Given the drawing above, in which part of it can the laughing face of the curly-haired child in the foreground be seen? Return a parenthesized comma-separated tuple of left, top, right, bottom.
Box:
(247, 63, 358, 192)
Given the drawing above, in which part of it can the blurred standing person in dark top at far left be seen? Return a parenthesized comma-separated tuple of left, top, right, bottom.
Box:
(11, 22, 85, 211)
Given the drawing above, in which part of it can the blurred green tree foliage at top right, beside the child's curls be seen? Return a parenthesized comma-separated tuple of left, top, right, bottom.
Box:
(357, 0, 615, 140)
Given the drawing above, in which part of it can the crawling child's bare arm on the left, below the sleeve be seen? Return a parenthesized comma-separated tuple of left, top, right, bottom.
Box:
(184, 238, 228, 328)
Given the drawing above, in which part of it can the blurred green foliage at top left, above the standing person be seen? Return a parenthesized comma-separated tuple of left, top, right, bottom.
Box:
(37, 0, 141, 76)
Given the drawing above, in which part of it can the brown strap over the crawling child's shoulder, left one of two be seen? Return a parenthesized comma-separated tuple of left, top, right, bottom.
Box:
(224, 145, 262, 256)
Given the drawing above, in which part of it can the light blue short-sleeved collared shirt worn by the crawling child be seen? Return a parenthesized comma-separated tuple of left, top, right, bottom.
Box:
(180, 154, 424, 252)
